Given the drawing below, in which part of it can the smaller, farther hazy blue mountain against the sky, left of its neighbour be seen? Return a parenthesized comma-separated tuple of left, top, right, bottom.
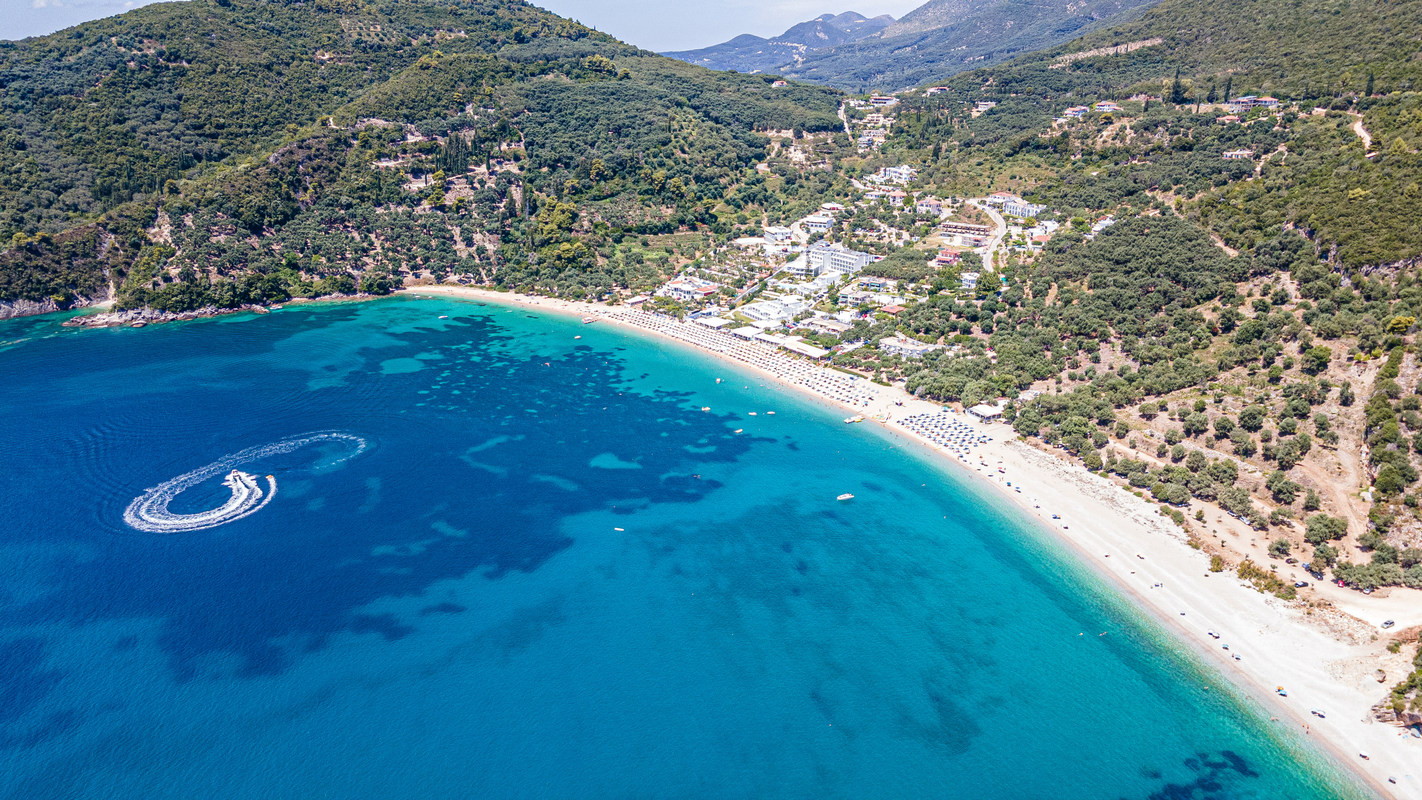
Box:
(664, 11, 893, 72)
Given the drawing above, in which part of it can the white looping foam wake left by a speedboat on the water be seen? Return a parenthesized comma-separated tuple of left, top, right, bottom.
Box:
(124, 432, 367, 533)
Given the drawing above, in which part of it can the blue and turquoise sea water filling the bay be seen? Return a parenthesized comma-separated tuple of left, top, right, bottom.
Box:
(0, 297, 1362, 800)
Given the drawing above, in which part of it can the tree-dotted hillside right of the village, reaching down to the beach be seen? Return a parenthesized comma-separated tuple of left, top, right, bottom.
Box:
(843, 0, 1422, 597)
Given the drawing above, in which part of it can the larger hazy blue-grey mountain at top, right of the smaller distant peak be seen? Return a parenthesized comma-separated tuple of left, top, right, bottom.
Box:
(775, 0, 1159, 91)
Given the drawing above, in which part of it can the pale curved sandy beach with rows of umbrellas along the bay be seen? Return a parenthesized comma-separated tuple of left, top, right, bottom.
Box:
(398, 286, 1422, 799)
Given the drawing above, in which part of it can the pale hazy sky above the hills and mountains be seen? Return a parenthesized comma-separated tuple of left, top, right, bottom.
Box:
(0, 0, 924, 51)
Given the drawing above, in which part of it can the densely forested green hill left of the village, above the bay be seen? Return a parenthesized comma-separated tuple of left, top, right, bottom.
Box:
(0, 0, 839, 307)
